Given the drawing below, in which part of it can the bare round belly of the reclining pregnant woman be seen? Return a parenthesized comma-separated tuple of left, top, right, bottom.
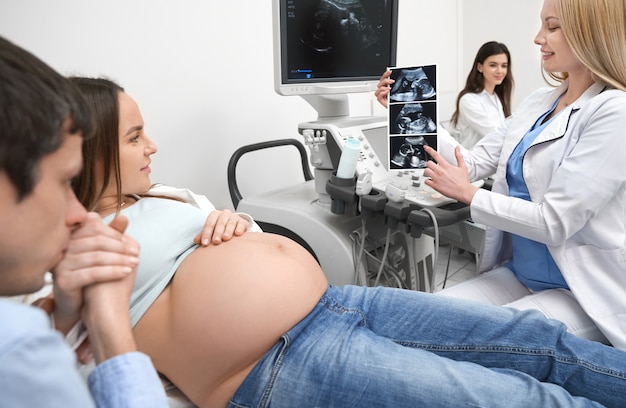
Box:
(134, 232, 328, 406)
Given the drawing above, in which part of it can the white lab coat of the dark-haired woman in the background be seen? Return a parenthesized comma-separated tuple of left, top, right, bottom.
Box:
(455, 89, 505, 149)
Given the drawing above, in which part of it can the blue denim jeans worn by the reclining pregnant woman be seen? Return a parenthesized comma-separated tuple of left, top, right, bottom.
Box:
(229, 286, 626, 408)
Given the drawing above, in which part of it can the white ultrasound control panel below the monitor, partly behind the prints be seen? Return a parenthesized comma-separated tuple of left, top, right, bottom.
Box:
(298, 117, 464, 207)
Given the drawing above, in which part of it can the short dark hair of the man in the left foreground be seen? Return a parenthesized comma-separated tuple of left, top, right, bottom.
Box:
(0, 37, 93, 200)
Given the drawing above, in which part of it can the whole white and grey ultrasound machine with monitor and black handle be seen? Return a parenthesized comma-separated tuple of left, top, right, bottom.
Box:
(228, 0, 482, 291)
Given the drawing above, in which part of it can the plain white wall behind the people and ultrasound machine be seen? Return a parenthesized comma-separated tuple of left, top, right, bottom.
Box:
(0, 0, 540, 208)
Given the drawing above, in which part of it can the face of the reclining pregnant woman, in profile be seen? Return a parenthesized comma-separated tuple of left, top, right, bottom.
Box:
(118, 92, 157, 194)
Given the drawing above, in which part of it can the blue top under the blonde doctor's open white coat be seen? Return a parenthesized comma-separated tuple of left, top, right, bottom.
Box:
(505, 99, 568, 291)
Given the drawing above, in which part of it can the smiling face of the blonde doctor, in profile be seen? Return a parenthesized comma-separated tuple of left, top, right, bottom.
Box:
(535, 0, 585, 75)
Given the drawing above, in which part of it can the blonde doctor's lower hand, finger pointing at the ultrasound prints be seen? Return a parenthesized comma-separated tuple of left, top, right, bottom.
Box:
(424, 146, 478, 205)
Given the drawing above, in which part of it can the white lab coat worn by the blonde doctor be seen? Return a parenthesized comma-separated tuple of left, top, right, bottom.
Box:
(439, 84, 626, 349)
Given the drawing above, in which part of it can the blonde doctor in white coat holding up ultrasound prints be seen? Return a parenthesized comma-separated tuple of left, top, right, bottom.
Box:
(424, 0, 626, 349)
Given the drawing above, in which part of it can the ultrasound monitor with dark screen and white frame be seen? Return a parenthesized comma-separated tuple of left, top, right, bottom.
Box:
(272, 0, 399, 118)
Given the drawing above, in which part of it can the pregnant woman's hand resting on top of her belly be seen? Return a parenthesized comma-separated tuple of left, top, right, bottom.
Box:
(193, 210, 250, 246)
